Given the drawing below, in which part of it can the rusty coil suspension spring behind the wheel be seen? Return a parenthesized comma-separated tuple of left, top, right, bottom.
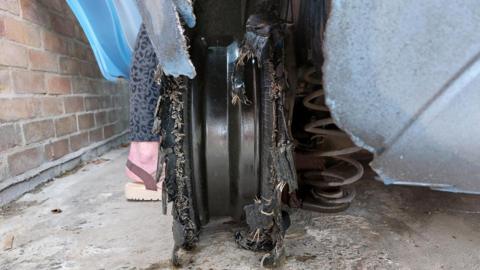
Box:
(301, 68, 364, 212)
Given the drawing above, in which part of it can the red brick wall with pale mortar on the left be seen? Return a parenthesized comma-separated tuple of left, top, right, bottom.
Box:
(0, 0, 128, 185)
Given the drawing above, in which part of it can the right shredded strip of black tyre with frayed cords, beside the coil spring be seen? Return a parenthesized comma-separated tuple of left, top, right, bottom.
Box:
(232, 12, 297, 267)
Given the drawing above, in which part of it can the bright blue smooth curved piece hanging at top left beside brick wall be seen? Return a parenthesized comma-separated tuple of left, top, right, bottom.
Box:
(67, 0, 142, 80)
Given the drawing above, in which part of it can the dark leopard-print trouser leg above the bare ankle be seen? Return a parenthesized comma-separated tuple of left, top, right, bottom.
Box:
(129, 25, 160, 142)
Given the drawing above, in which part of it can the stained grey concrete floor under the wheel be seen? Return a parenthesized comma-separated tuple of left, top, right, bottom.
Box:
(0, 148, 480, 269)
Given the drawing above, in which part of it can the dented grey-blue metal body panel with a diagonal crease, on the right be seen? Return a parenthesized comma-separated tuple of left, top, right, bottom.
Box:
(324, 0, 480, 193)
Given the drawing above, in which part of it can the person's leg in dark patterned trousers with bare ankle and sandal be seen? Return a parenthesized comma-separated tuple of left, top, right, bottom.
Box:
(125, 25, 160, 200)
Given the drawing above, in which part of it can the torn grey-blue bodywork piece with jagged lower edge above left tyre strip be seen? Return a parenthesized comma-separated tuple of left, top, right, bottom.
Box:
(137, 0, 196, 79)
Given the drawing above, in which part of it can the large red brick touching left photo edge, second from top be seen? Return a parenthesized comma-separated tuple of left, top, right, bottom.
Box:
(3, 17, 41, 47)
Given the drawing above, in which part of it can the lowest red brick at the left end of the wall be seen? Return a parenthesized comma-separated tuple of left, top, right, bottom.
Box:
(7, 147, 44, 176)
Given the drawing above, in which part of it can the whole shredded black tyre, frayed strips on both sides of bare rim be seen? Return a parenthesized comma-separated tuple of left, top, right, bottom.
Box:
(154, 6, 297, 267)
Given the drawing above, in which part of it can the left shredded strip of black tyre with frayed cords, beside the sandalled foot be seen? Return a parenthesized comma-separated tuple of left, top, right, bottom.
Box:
(154, 73, 198, 265)
